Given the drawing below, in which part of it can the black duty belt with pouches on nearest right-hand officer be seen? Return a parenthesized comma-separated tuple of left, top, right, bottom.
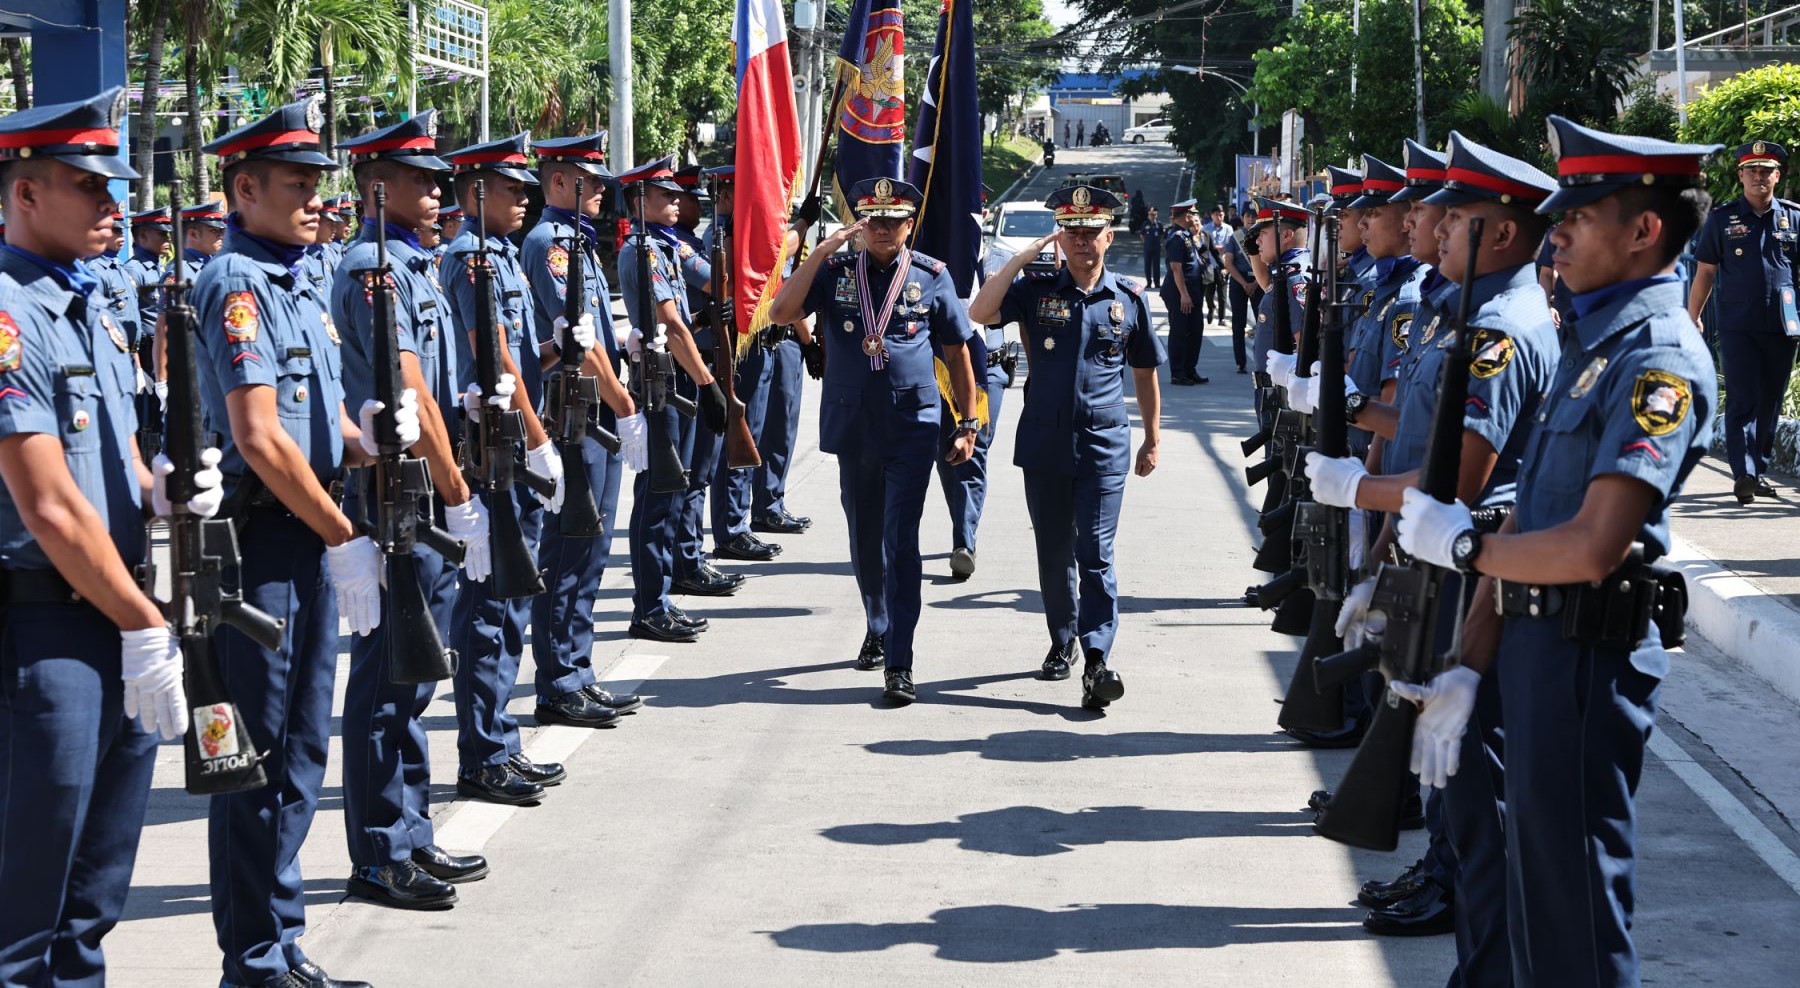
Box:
(1494, 561, 1688, 650)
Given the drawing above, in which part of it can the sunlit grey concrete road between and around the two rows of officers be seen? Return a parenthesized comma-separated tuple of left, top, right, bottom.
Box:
(108, 146, 1800, 988)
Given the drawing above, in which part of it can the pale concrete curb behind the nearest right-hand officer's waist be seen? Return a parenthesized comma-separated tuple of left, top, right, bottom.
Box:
(1663, 538, 1800, 704)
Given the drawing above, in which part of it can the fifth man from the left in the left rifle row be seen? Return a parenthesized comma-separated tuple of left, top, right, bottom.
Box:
(518, 131, 644, 720)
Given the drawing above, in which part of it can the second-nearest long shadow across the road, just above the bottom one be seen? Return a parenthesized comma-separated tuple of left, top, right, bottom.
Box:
(821, 806, 1312, 858)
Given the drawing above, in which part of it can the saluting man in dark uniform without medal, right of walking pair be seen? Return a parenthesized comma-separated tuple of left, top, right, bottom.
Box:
(968, 185, 1166, 711)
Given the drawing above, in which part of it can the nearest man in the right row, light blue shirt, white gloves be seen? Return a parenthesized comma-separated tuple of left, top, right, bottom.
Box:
(1393, 117, 1717, 986)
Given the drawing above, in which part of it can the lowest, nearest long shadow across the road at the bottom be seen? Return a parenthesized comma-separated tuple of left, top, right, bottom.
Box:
(769, 902, 1368, 963)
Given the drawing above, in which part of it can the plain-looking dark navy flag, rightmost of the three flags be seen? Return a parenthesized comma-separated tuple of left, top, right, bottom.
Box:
(907, 0, 981, 299)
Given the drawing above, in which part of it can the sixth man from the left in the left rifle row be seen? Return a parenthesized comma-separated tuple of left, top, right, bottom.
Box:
(619, 157, 725, 642)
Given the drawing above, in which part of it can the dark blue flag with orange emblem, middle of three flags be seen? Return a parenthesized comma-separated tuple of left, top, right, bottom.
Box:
(832, 0, 905, 216)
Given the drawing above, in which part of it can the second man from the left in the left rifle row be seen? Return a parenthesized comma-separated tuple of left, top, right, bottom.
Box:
(193, 97, 387, 986)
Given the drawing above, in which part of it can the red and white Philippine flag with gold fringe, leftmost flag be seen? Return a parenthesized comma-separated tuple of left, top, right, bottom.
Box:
(731, 0, 801, 338)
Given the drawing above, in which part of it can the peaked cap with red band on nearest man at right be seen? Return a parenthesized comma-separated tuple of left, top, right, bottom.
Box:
(1537, 115, 1723, 212)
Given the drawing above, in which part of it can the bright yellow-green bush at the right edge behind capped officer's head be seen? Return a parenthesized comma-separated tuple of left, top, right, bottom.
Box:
(1681, 63, 1800, 202)
